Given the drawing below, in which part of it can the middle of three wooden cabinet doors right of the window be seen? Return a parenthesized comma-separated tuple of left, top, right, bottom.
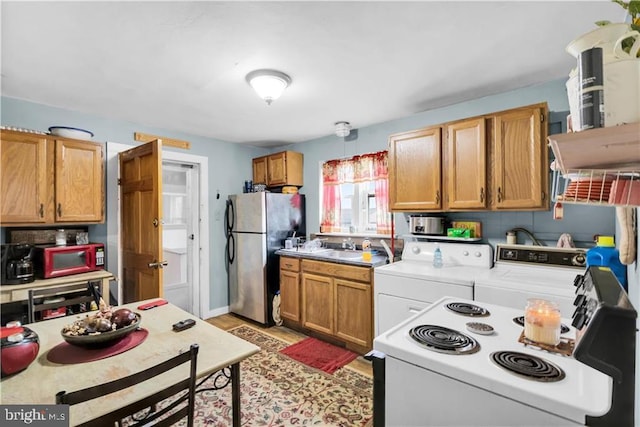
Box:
(445, 117, 487, 210)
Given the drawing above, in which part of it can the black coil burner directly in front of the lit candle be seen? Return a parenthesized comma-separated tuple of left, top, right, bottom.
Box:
(491, 351, 565, 382)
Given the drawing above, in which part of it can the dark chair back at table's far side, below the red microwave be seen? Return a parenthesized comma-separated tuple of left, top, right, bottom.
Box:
(28, 281, 100, 323)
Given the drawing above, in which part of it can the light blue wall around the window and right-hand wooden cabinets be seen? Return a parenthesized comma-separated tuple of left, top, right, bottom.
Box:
(288, 79, 615, 246)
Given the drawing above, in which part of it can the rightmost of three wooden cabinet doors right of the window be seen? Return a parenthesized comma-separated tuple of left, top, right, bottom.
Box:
(491, 104, 549, 209)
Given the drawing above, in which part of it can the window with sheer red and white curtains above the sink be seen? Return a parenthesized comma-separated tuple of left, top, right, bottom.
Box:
(320, 151, 391, 234)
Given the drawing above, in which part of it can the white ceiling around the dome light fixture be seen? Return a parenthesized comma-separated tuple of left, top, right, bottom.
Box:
(1, 1, 625, 146)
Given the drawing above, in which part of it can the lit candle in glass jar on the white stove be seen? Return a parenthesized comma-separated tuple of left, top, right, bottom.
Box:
(524, 299, 561, 345)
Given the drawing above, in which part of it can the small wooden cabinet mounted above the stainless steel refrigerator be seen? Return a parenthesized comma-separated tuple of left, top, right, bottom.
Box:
(253, 151, 304, 187)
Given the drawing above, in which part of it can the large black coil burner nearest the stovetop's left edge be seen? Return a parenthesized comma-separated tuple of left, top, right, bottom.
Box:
(409, 325, 480, 355)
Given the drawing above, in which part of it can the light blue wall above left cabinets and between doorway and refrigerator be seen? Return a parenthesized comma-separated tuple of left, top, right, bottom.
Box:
(0, 97, 268, 310)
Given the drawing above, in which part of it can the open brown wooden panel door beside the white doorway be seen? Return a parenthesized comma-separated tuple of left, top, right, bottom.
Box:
(120, 140, 164, 304)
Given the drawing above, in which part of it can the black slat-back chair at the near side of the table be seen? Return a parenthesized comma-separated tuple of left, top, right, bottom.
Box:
(56, 344, 198, 427)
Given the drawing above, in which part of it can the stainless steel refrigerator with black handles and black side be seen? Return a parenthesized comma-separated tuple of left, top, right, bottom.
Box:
(225, 192, 306, 325)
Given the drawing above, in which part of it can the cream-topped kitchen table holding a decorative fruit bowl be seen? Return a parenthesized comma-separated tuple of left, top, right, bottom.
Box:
(0, 300, 260, 426)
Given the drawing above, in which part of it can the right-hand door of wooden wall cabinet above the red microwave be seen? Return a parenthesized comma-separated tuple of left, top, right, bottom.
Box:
(55, 140, 104, 222)
